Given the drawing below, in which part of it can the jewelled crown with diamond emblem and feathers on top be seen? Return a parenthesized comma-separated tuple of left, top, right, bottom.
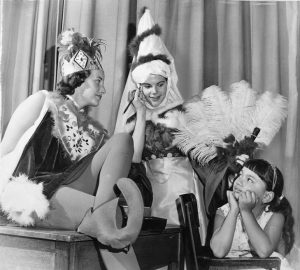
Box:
(57, 29, 104, 76)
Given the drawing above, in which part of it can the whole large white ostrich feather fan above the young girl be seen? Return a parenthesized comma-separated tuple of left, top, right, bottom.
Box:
(174, 81, 287, 165)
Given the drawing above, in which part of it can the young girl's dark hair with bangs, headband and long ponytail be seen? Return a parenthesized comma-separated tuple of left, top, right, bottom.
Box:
(244, 159, 295, 254)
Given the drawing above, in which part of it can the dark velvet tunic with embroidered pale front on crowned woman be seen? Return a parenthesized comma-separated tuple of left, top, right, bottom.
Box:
(13, 93, 107, 197)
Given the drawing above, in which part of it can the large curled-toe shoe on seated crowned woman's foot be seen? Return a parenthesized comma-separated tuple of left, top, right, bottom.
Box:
(77, 178, 144, 252)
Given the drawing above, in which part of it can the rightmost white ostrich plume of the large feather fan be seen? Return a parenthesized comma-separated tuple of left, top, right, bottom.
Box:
(254, 91, 287, 145)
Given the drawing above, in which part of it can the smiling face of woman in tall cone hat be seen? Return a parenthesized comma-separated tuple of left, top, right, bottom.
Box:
(141, 74, 167, 107)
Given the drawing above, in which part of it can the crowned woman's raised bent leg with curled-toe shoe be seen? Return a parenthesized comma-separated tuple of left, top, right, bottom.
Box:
(70, 133, 144, 249)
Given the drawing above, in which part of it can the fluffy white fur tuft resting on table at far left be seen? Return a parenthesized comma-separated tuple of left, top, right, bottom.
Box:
(0, 174, 49, 226)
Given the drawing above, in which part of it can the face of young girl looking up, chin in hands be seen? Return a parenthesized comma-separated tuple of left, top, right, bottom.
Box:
(233, 167, 266, 201)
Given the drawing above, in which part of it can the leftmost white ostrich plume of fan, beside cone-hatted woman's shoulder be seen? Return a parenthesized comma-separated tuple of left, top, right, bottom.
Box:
(174, 86, 228, 164)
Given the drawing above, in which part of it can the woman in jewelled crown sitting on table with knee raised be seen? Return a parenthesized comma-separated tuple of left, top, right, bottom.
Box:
(0, 30, 143, 269)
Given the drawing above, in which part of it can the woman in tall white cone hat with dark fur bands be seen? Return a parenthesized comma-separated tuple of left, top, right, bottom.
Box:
(116, 9, 206, 239)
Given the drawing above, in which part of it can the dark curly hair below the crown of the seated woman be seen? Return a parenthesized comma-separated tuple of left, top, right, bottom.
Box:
(56, 70, 91, 96)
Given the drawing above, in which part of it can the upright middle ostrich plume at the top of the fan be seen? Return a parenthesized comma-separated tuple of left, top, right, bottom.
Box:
(229, 81, 257, 141)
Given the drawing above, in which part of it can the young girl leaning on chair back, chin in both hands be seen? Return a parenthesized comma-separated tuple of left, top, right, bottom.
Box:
(210, 159, 294, 269)
